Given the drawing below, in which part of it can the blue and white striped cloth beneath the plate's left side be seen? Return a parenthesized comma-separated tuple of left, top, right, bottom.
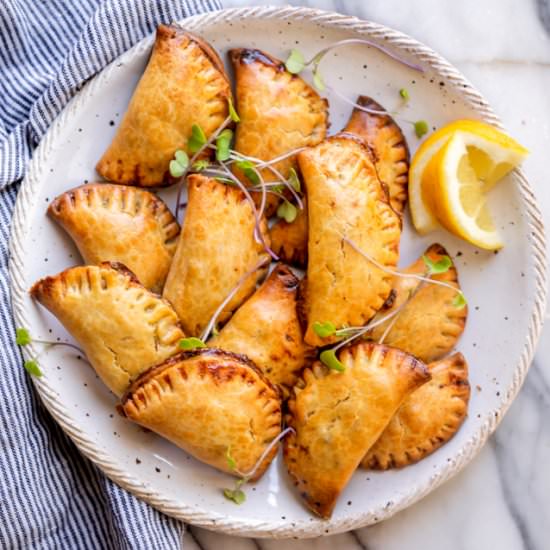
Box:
(0, 0, 220, 550)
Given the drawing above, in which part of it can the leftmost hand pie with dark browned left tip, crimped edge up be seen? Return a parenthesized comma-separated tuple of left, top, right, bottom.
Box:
(30, 262, 185, 395)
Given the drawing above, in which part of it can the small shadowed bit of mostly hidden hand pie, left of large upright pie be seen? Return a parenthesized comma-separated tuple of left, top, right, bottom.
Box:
(270, 199, 308, 268)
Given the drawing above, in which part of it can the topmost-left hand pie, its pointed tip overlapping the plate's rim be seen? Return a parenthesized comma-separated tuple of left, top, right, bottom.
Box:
(96, 25, 231, 187)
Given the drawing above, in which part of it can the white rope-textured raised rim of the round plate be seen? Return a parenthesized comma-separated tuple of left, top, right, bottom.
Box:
(9, 6, 547, 538)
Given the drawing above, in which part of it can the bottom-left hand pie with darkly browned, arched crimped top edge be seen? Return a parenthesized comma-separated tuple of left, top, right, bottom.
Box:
(122, 348, 281, 480)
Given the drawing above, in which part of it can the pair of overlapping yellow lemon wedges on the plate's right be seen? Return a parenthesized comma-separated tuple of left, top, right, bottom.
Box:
(409, 120, 528, 250)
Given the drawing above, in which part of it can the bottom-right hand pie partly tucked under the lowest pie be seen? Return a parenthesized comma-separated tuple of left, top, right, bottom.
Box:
(361, 353, 470, 470)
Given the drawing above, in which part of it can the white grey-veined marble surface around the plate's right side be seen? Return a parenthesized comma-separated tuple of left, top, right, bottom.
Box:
(184, 0, 550, 550)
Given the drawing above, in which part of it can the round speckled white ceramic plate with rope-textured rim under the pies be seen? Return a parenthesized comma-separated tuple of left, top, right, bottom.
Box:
(11, 8, 546, 537)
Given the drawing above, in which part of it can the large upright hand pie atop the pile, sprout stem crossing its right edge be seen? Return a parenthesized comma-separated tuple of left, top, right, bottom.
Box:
(298, 134, 401, 346)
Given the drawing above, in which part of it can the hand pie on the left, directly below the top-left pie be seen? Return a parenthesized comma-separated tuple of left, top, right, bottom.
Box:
(48, 183, 179, 292)
